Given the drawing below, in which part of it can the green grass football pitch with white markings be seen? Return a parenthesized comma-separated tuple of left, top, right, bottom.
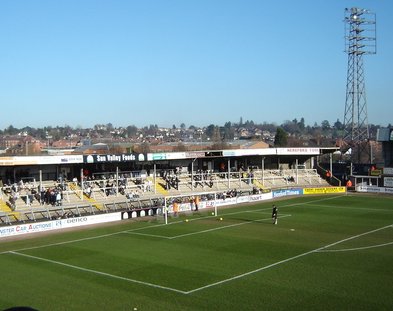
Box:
(0, 194, 393, 311)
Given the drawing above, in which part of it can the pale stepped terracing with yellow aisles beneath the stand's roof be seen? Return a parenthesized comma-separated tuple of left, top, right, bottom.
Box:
(0, 169, 329, 227)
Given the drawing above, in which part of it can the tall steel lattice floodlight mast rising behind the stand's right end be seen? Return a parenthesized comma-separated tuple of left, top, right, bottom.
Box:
(343, 8, 377, 163)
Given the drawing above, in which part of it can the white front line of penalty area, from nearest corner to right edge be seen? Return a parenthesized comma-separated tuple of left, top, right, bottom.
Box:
(186, 225, 392, 295)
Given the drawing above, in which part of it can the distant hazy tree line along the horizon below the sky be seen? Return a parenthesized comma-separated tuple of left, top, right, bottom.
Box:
(0, 117, 391, 144)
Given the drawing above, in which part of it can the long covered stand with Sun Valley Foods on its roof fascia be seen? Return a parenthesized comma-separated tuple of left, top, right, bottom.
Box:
(0, 148, 336, 224)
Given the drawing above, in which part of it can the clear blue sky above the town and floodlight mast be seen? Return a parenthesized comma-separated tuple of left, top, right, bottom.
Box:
(0, 0, 393, 129)
